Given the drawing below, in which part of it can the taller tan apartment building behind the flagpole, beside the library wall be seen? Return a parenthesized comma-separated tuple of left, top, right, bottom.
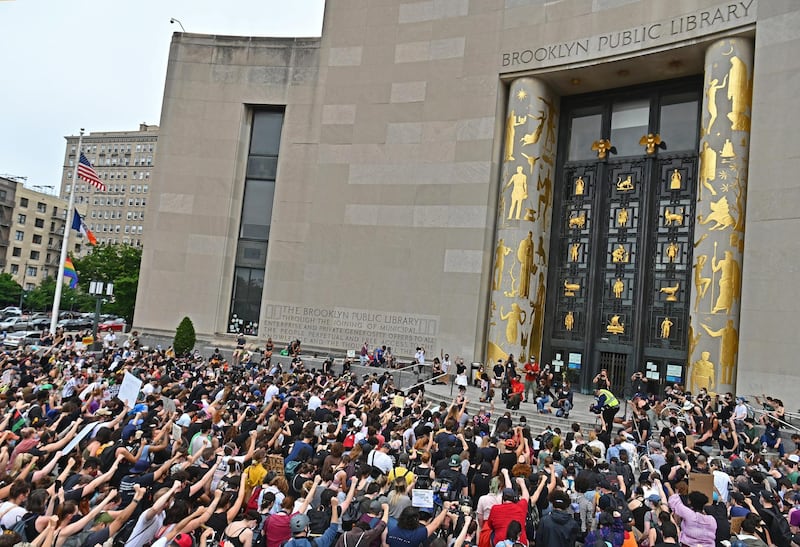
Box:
(61, 123, 158, 254)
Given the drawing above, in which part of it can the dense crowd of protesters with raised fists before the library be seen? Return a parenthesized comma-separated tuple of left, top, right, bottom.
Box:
(0, 336, 800, 547)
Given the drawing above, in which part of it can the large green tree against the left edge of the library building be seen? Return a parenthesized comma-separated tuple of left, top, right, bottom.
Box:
(72, 245, 142, 323)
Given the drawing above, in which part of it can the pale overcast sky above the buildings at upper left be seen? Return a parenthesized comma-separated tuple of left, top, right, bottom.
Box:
(0, 0, 324, 193)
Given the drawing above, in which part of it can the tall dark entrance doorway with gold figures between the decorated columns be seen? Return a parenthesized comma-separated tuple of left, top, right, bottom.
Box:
(542, 80, 701, 396)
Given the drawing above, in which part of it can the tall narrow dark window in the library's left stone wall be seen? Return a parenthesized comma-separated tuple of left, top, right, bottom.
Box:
(228, 110, 283, 334)
